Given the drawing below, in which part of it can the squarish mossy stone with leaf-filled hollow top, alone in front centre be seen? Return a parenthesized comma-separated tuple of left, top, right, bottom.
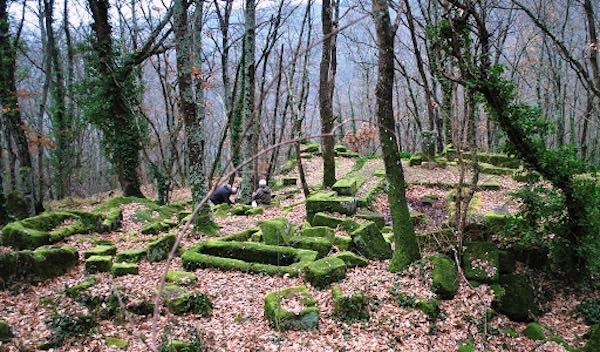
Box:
(265, 286, 319, 330)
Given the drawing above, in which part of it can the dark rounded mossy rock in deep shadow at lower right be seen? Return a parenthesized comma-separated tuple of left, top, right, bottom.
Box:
(494, 274, 540, 322)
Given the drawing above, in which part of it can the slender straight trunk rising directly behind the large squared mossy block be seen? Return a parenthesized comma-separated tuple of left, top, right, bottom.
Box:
(319, 0, 336, 188)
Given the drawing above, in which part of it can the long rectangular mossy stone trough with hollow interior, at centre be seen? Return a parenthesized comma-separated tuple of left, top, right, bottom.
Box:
(181, 241, 317, 276)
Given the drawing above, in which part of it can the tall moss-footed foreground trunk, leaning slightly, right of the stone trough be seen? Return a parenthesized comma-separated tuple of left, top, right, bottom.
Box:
(373, 0, 421, 272)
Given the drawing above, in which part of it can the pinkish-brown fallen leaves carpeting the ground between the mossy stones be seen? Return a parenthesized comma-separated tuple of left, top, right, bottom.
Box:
(0, 157, 600, 352)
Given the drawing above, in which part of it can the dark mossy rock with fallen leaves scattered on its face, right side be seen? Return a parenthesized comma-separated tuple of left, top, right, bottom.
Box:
(463, 241, 500, 283)
